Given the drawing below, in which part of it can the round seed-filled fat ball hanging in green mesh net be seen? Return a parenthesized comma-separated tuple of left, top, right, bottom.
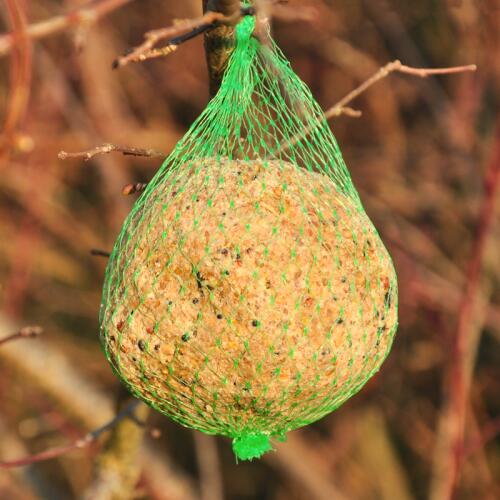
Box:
(100, 13, 397, 460)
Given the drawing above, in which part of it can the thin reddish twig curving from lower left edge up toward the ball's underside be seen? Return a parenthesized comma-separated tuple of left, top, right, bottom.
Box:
(0, 401, 140, 469)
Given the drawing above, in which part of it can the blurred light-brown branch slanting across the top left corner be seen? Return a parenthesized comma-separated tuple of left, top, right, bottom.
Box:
(0, 0, 133, 57)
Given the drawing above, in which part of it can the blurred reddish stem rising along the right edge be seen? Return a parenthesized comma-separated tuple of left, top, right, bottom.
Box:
(433, 121, 500, 499)
